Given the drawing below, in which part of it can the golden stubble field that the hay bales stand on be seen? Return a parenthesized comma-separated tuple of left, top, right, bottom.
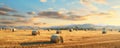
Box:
(0, 30, 120, 48)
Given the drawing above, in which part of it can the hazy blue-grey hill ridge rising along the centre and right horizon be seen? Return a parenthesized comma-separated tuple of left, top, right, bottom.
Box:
(44, 24, 120, 30)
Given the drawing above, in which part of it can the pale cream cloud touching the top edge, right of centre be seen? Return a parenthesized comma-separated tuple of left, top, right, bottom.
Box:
(80, 0, 109, 11)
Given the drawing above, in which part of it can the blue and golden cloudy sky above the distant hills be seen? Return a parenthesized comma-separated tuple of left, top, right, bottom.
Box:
(0, 0, 120, 26)
